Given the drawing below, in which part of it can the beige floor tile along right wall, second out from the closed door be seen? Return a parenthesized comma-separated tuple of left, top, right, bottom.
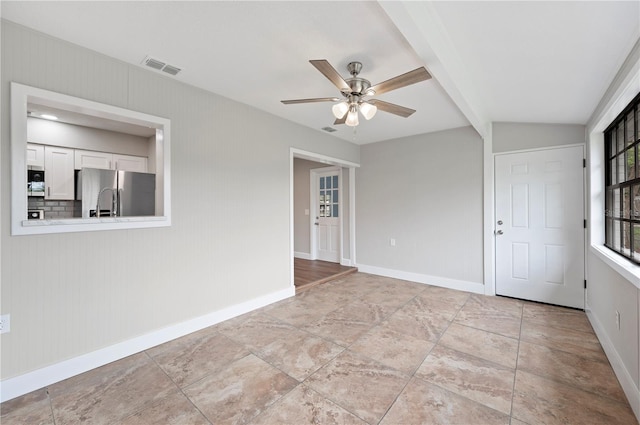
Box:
(521, 322, 606, 361)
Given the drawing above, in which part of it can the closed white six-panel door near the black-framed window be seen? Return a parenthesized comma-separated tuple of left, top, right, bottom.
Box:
(495, 146, 584, 308)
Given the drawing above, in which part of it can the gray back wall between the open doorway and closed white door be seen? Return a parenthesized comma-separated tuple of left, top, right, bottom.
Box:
(356, 127, 483, 283)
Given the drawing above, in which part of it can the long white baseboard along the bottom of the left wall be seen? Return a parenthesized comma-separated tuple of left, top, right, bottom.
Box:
(0, 286, 295, 402)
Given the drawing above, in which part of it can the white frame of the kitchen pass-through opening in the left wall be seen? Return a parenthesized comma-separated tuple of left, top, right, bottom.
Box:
(11, 82, 171, 236)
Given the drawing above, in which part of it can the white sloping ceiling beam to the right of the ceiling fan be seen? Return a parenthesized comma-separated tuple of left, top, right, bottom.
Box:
(378, 1, 490, 138)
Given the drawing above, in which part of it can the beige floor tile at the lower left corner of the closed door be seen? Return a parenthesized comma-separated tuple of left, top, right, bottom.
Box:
(454, 294, 522, 339)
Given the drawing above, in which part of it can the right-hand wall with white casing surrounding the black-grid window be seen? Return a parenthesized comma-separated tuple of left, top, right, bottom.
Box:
(586, 35, 640, 408)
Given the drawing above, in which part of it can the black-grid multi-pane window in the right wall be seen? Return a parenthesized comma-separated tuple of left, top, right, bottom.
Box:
(604, 95, 640, 264)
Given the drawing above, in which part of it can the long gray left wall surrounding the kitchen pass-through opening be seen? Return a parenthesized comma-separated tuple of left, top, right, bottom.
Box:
(0, 21, 359, 379)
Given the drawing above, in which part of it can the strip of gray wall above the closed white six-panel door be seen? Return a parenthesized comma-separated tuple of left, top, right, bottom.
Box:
(493, 122, 586, 153)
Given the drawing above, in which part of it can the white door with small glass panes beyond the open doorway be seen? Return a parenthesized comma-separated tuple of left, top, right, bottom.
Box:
(312, 169, 340, 263)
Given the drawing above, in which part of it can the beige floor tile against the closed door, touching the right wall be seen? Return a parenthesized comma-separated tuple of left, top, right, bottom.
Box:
(522, 303, 594, 333)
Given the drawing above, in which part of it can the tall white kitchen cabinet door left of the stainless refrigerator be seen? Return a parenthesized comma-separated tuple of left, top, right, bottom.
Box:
(44, 146, 75, 200)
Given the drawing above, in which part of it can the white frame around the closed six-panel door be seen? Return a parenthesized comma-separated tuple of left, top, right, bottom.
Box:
(492, 144, 589, 306)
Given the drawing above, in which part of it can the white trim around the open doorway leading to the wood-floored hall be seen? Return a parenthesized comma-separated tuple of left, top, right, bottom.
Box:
(289, 148, 360, 288)
